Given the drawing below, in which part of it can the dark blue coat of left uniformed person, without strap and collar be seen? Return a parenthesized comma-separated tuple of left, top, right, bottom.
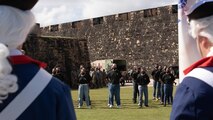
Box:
(0, 63, 76, 120)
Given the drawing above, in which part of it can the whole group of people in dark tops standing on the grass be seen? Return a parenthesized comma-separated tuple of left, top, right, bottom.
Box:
(52, 64, 175, 108)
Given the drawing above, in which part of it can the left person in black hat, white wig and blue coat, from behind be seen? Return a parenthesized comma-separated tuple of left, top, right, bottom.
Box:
(0, 0, 76, 120)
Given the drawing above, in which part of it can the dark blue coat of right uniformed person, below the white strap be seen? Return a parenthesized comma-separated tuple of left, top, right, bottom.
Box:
(170, 67, 213, 120)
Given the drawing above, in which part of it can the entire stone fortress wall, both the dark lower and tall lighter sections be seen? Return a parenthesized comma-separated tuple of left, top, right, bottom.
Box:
(26, 5, 178, 87)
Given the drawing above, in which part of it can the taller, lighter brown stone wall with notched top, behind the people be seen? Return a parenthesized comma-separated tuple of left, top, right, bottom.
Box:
(41, 6, 178, 71)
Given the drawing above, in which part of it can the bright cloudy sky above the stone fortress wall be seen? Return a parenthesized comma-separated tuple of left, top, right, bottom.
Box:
(32, 0, 178, 27)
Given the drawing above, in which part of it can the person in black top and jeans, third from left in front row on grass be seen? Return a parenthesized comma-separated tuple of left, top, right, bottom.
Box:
(136, 68, 150, 107)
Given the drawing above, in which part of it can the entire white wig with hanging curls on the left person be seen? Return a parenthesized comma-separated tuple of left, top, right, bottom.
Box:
(0, 5, 35, 103)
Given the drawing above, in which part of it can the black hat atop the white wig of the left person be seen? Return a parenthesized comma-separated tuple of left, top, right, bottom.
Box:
(0, 0, 38, 10)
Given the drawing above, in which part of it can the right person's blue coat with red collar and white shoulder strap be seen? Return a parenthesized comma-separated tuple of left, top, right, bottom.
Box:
(170, 57, 213, 120)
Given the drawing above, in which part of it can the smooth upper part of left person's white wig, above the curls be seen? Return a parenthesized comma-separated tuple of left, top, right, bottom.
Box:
(0, 6, 35, 49)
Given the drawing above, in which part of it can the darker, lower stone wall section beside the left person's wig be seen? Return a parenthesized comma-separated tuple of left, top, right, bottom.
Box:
(23, 34, 90, 88)
